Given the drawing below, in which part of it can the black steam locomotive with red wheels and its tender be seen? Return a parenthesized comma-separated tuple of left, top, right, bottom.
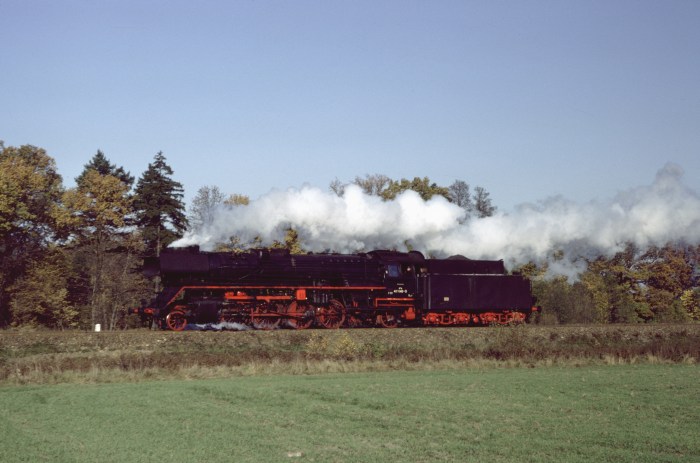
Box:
(134, 246, 537, 331)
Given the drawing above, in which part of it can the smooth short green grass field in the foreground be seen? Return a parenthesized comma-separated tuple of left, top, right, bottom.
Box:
(0, 364, 700, 463)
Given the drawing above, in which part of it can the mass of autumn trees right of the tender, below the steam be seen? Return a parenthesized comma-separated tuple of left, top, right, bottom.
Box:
(524, 243, 700, 323)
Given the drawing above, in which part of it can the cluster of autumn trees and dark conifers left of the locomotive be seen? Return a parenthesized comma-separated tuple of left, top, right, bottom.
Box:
(0, 143, 187, 329)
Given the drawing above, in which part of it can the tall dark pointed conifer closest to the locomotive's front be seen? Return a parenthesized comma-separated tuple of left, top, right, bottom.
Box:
(134, 151, 187, 257)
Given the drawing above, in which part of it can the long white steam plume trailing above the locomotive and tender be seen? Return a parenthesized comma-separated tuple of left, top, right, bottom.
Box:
(173, 163, 700, 275)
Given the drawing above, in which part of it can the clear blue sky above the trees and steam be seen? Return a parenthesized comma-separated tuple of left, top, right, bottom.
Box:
(0, 0, 700, 210)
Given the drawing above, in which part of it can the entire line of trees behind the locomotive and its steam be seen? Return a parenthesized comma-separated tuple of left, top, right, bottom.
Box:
(0, 142, 700, 329)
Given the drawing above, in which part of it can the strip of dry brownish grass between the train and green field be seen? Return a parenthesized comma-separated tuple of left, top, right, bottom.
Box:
(0, 324, 700, 385)
